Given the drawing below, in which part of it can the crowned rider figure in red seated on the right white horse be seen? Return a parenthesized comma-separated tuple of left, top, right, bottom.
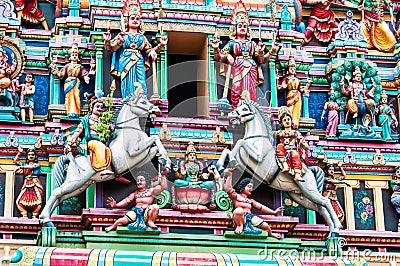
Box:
(275, 106, 308, 182)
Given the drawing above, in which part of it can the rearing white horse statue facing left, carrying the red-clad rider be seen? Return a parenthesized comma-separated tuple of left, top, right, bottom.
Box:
(217, 99, 342, 236)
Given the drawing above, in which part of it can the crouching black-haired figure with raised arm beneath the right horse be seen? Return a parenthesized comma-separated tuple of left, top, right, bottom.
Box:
(225, 169, 283, 239)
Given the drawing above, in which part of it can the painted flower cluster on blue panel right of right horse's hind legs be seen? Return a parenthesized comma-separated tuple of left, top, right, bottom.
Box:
(354, 190, 374, 229)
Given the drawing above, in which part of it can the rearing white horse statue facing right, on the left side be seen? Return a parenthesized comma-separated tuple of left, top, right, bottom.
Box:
(39, 94, 171, 227)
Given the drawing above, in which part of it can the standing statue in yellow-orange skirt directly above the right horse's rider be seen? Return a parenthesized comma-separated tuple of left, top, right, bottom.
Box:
(278, 56, 311, 129)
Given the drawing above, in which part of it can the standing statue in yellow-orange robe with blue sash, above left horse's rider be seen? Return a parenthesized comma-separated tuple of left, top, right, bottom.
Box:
(50, 44, 93, 118)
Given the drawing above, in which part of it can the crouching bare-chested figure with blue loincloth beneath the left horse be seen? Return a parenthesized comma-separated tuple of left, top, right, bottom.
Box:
(105, 169, 168, 232)
